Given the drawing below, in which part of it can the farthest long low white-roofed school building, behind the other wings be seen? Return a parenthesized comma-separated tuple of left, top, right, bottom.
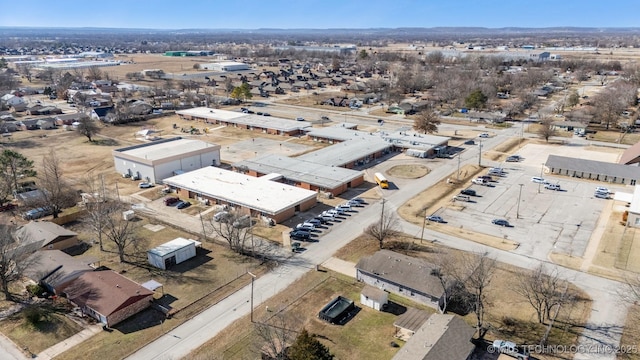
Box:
(176, 107, 311, 136)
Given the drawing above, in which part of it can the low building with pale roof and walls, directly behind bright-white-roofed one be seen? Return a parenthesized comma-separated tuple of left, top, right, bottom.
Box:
(233, 154, 364, 196)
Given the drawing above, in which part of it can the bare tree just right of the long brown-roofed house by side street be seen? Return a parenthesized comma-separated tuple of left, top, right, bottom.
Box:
(454, 253, 496, 339)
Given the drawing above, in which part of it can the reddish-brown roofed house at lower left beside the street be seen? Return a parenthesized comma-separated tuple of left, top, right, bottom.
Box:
(64, 270, 153, 327)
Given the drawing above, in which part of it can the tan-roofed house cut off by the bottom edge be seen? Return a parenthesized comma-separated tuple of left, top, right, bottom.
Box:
(392, 314, 475, 360)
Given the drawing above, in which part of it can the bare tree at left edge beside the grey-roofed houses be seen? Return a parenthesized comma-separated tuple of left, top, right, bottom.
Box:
(0, 225, 30, 301)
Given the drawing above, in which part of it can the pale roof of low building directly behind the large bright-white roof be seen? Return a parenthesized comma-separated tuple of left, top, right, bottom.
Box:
(234, 154, 362, 189)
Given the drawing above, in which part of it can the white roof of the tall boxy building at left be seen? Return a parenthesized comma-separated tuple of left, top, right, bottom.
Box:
(114, 137, 220, 161)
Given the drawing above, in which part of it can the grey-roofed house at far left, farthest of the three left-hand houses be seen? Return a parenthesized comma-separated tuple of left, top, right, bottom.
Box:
(17, 221, 80, 251)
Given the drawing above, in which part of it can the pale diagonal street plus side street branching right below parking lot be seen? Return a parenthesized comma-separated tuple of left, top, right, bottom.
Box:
(128, 124, 626, 360)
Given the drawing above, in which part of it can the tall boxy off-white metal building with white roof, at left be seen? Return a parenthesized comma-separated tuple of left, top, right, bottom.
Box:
(112, 137, 220, 183)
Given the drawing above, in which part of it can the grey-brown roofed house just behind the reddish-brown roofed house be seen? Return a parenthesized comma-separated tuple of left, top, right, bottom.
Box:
(25, 250, 98, 294)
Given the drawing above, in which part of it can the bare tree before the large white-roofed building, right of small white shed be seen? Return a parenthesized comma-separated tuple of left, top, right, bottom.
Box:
(210, 211, 253, 254)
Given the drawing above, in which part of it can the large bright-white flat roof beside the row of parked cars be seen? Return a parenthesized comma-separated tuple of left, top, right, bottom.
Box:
(163, 166, 316, 215)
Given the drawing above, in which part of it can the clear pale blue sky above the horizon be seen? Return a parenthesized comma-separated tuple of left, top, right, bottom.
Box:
(0, 0, 640, 29)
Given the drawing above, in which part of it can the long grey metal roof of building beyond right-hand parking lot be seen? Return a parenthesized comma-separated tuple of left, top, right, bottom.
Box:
(545, 155, 640, 180)
